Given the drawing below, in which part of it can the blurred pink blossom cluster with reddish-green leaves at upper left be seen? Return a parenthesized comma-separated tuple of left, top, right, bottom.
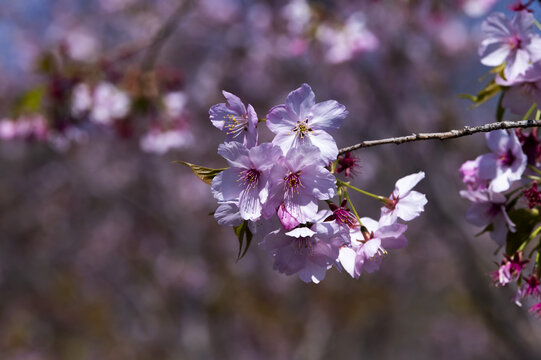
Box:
(0, 51, 193, 154)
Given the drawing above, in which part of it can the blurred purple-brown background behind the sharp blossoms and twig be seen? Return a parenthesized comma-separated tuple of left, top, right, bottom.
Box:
(0, 0, 541, 360)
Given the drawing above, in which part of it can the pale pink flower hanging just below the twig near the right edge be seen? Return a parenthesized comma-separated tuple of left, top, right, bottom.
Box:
(477, 130, 528, 192)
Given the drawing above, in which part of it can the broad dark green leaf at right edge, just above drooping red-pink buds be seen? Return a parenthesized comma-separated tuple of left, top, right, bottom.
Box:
(505, 209, 541, 256)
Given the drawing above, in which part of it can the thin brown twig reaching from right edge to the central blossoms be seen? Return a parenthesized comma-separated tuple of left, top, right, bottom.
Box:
(338, 120, 541, 154)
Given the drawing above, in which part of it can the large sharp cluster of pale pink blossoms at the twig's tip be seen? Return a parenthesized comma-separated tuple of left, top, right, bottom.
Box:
(198, 84, 427, 283)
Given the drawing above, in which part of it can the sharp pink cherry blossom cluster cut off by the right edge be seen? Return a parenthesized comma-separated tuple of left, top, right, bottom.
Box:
(459, 5, 541, 315)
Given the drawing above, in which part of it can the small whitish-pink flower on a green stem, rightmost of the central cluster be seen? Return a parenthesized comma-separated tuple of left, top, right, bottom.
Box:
(379, 171, 427, 225)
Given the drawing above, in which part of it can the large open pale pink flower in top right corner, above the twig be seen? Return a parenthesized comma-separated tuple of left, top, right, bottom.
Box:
(479, 11, 541, 81)
